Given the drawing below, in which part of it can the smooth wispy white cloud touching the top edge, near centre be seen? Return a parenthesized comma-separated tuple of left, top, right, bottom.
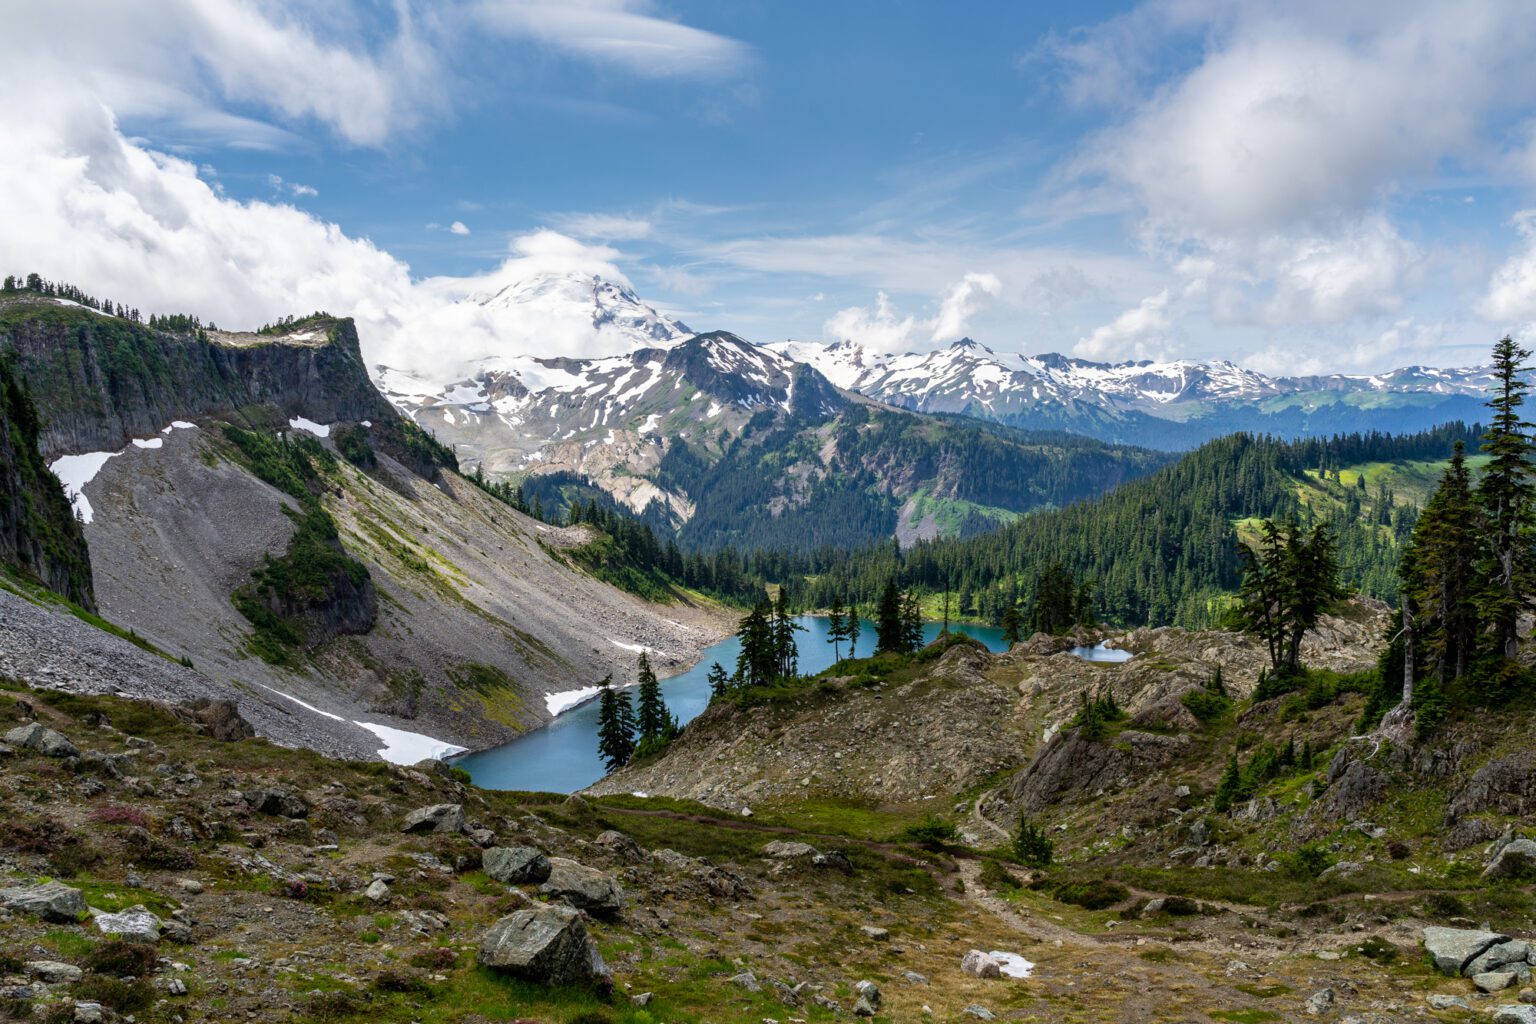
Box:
(472, 0, 753, 78)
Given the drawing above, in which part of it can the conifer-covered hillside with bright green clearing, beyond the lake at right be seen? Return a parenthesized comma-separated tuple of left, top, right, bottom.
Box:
(803, 424, 1478, 626)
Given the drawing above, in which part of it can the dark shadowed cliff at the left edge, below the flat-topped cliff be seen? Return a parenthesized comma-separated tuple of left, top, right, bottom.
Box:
(0, 359, 95, 608)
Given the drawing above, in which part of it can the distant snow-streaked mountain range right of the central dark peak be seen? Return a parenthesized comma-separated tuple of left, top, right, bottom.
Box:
(770, 338, 1490, 448)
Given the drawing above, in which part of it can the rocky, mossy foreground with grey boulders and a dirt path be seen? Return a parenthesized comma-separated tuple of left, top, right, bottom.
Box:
(0, 604, 1536, 1024)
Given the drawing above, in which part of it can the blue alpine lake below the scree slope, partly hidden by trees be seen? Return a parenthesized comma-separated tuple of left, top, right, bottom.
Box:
(453, 616, 1006, 792)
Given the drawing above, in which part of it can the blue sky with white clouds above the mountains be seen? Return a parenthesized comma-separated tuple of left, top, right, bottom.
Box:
(9, 0, 1536, 373)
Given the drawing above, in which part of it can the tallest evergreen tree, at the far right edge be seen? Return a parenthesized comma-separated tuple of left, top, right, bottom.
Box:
(1478, 338, 1536, 657)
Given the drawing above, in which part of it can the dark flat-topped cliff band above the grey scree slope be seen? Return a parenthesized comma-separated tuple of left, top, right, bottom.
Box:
(0, 295, 398, 457)
